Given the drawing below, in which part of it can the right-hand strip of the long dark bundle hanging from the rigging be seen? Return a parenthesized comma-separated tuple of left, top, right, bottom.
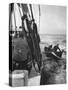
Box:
(33, 19, 42, 71)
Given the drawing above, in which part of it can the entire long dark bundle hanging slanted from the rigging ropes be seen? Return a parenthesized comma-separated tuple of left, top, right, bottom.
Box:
(22, 15, 41, 69)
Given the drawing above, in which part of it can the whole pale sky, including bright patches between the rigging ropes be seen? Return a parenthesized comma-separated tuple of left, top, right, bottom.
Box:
(13, 5, 66, 34)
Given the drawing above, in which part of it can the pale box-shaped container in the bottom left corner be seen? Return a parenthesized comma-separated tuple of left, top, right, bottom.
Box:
(9, 70, 28, 87)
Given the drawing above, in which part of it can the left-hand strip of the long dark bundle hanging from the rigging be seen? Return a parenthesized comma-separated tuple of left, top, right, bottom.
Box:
(22, 15, 35, 60)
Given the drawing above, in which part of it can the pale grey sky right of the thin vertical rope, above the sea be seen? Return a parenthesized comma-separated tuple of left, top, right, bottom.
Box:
(32, 5, 66, 34)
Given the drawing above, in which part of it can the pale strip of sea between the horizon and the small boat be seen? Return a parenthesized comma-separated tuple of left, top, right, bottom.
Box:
(40, 34, 66, 51)
